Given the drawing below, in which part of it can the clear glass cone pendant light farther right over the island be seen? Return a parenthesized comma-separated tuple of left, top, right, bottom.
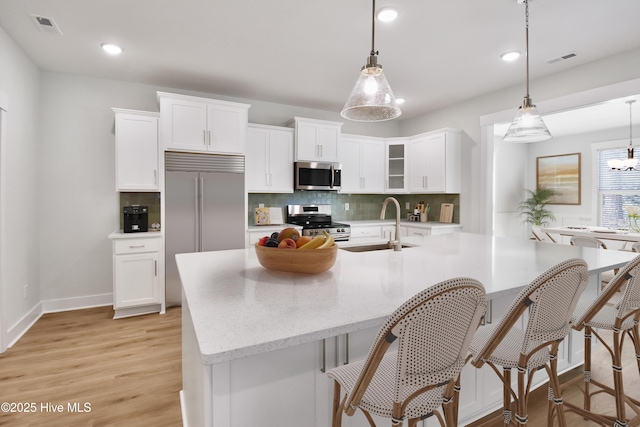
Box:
(502, 0, 551, 142)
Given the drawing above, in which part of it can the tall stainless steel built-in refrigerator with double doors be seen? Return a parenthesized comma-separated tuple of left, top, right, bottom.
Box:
(163, 152, 246, 307)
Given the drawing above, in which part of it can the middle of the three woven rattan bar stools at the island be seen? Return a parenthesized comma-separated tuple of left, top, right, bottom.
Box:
(468, 258, 589, 426)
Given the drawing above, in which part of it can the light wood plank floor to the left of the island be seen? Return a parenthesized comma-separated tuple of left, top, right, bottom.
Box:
(0, 307, 182, 427)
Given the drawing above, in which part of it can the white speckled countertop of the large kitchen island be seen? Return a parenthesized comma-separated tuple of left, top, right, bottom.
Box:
(176, 233, 635, 365)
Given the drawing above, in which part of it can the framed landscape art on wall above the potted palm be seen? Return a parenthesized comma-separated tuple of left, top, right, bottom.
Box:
(536, 153, 580, 205)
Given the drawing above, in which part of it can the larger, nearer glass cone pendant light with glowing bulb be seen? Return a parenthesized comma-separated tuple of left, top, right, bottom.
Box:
(340, 0, 402, 122)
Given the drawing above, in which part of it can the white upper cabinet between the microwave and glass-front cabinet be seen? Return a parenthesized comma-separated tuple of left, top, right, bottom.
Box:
(339, 135, 385, 194)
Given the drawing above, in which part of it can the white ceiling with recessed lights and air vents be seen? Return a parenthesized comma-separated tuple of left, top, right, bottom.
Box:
(0, 0, 640, 127)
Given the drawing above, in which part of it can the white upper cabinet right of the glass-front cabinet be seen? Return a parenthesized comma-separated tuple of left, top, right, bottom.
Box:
(407, 129, 461, 193)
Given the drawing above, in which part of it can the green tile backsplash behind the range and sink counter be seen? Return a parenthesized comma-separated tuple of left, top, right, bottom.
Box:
(247, 191, 460, 225)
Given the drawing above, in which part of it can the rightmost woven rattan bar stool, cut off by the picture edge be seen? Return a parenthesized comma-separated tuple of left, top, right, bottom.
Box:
(549, 255, 640, 427)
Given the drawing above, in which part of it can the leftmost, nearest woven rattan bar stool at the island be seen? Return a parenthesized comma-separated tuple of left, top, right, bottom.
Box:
(327, 278, 486, 427)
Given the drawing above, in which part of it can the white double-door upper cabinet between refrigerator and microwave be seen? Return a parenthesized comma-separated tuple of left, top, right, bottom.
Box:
(245, 124, 293, 193)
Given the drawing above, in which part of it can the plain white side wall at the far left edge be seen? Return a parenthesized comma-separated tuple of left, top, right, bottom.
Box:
(0, 28, 41, 344)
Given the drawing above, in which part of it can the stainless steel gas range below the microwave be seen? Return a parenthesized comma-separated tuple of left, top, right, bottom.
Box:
(287, 205, 351, 242)
